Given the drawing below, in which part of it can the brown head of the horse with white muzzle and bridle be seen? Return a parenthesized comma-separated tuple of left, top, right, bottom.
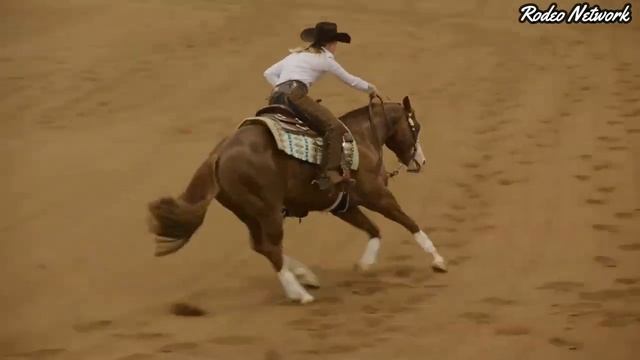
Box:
(385, 96, 427, 172)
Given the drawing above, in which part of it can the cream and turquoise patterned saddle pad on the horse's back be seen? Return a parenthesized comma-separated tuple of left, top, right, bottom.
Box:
(238, 116, 360, 170)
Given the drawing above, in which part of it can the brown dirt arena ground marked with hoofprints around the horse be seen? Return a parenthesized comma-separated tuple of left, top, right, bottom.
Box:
(0, 0, 640, 360)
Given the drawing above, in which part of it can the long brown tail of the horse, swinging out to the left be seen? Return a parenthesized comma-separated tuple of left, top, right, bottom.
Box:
(148, 140, 224, 256)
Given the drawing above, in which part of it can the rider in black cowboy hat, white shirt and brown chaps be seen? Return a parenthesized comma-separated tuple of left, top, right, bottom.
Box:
(264, 22, 377, 190)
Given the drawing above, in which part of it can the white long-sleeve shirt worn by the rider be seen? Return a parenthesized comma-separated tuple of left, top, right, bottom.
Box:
(264, 49, 369, 92)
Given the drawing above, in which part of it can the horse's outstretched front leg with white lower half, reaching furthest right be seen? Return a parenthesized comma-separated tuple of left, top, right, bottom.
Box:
(362, 188, 447, 271)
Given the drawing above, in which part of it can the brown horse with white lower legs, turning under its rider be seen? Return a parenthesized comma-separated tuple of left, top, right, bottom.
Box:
(148, 96, 447, 304)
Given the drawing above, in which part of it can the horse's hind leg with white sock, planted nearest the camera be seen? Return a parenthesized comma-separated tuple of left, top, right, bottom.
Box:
(253, 211, 314, 304)
